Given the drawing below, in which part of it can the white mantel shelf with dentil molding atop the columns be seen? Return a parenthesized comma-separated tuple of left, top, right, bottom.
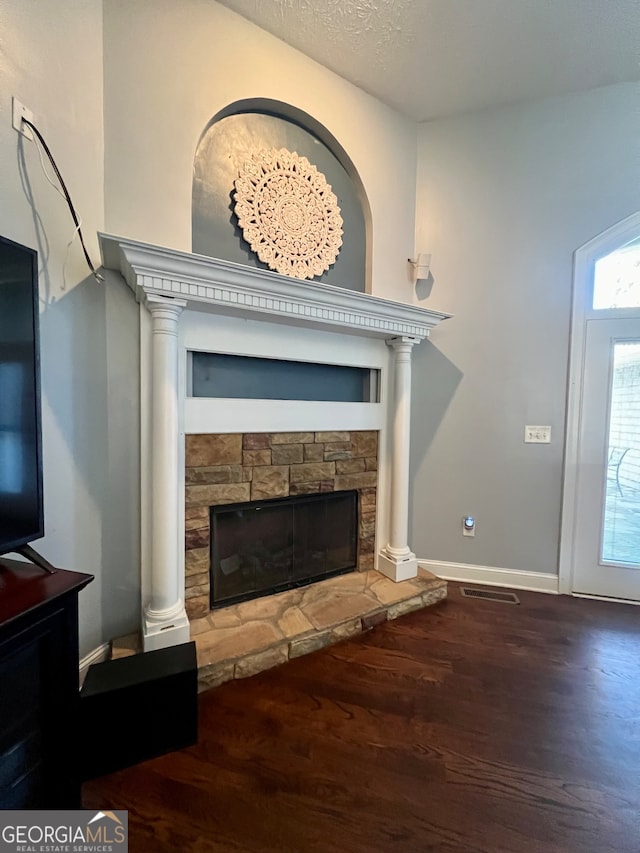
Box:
(98, 233, 450, 340)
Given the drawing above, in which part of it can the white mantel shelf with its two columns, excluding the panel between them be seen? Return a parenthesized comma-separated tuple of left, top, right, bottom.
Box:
(99, 234, 449, 650)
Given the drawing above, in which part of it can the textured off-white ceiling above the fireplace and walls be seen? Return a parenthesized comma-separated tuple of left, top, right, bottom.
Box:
(220, 0, 640, 121)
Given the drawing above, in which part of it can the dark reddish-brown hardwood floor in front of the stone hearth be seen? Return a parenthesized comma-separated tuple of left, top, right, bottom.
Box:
(84, 584, 640, 853)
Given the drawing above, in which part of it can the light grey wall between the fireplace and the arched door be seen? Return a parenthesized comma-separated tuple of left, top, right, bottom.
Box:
(412, 84, 640, 574)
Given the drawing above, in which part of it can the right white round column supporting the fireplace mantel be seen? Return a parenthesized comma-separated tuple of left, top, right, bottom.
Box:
(378, 336, 419, 581)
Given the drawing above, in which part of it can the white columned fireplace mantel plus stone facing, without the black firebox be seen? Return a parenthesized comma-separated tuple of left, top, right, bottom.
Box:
(100, 234, 448, 651)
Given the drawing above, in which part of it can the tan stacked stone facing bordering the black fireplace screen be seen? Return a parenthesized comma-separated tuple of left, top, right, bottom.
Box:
(185, 431, 378, 619)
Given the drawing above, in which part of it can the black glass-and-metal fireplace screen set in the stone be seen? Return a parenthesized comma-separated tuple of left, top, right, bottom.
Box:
(211, 491, 358, 608)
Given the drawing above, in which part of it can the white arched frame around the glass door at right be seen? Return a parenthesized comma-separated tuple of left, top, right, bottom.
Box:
(558, 211, 640, 595)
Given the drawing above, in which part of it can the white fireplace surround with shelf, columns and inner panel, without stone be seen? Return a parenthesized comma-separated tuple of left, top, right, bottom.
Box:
(99, 234, 448, 651)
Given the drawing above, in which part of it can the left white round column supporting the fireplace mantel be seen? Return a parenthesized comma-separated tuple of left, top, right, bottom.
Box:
(143, 294, 189, 651)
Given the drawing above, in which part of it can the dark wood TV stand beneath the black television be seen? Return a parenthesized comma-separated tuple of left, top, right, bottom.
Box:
(0, 557, 93, 809)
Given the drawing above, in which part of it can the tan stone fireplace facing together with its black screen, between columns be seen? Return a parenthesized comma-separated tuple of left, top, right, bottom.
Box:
(185, 430, 378, 619)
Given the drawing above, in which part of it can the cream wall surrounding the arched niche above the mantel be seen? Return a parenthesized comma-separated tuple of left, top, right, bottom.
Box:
(104, 0, 416, 302)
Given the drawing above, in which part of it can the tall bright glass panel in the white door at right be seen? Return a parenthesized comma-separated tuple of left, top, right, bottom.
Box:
(601, 341, 640, 567)
